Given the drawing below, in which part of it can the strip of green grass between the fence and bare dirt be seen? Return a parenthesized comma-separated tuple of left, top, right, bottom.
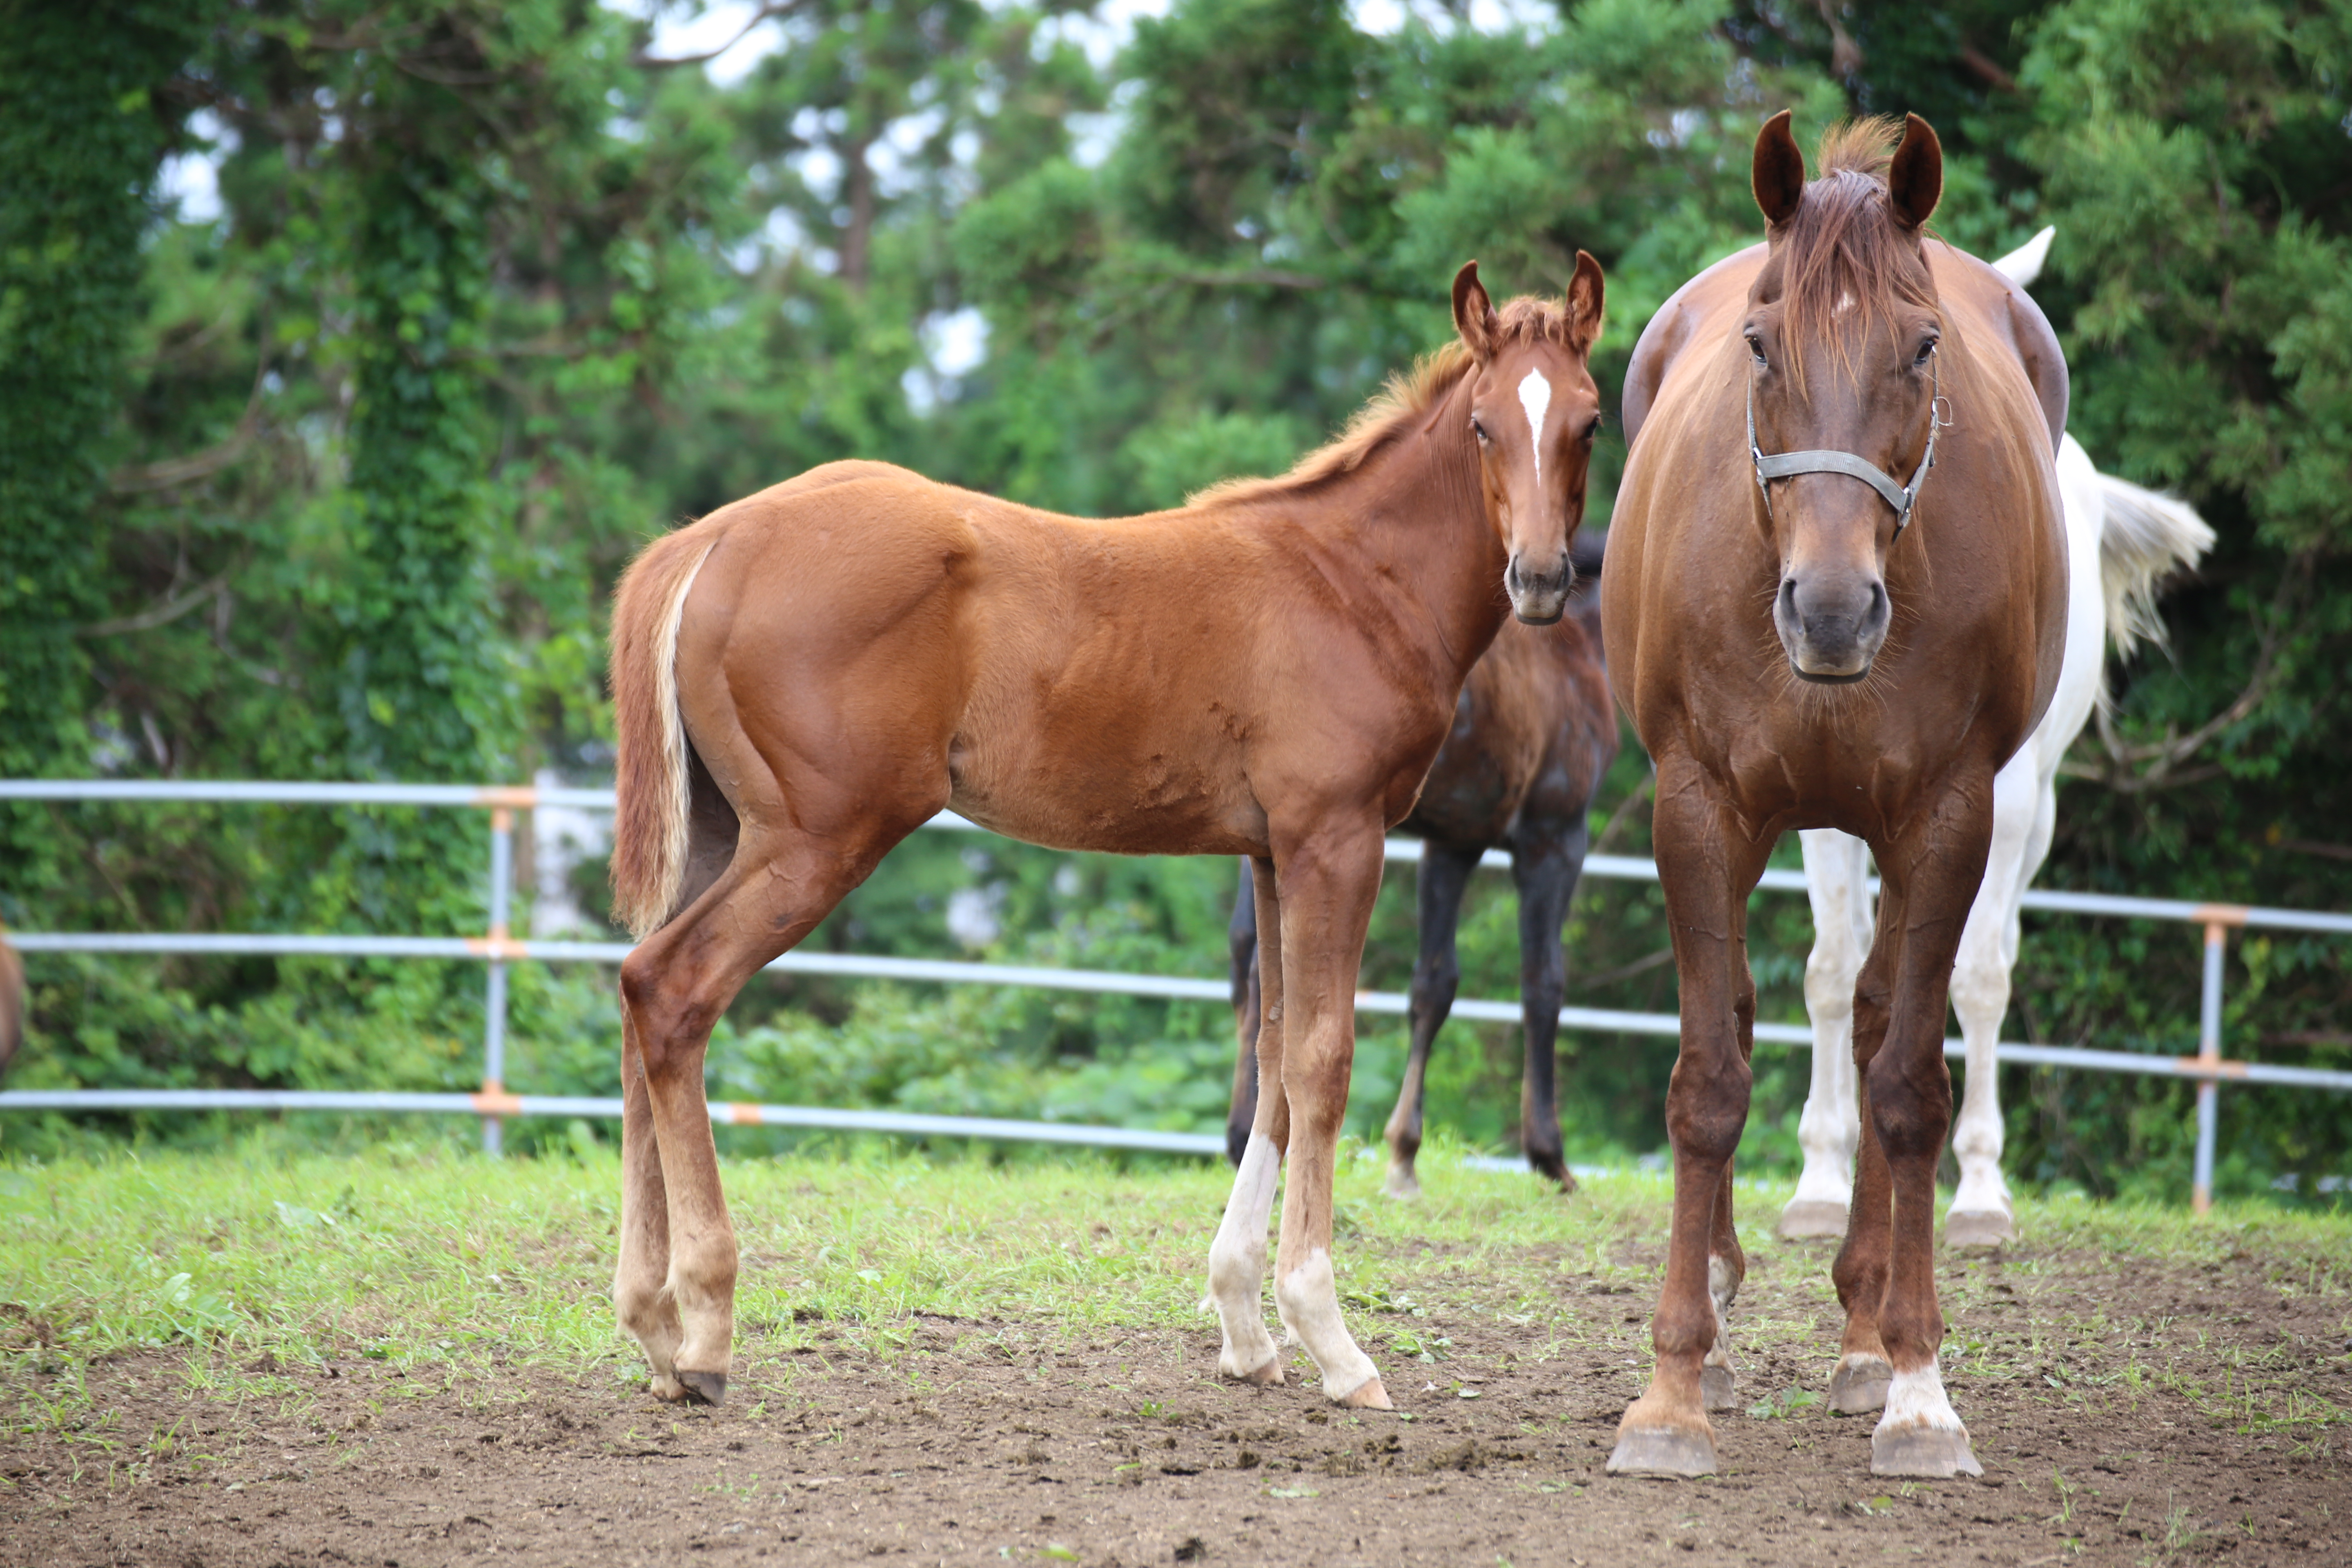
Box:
(0, 1138, 2352, 1429)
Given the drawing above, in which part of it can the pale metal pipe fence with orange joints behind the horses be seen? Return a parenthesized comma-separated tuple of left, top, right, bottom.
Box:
(0, 778, 2352, 1213)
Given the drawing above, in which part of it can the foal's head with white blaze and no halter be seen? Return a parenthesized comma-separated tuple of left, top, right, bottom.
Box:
(1454, 252, 1602, 625)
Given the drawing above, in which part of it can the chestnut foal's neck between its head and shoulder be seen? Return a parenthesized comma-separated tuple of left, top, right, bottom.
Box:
(1305, 376, 1508, 689)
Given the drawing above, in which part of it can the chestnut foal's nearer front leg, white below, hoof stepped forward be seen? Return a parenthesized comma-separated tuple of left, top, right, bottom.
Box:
(1268, 816, 1390, 1410)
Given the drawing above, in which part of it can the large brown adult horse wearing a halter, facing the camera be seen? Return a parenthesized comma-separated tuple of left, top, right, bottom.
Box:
(1604, 113, 2067, 1476)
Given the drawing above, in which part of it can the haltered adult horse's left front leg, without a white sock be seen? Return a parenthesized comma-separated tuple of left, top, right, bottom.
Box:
(1609, 757, 1771, 1476)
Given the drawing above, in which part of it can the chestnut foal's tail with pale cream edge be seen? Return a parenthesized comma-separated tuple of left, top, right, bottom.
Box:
(612, 524, 717, 935)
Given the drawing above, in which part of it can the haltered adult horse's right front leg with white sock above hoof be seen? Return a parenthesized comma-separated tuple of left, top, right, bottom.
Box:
(1863, 799, 1992, 1476)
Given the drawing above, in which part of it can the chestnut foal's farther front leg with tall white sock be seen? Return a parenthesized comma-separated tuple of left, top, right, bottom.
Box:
(1202, 858, 1291, 1382)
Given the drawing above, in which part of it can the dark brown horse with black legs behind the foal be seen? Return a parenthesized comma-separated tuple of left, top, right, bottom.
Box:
(1225, 534, 1618, 1196)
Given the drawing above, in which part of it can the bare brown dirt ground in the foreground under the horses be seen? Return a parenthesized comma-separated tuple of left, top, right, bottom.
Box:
(0, 1246, 2352, 1568)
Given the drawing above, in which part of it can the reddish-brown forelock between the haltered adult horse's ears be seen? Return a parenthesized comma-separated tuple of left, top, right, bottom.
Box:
(1773, 115, 1936, 385)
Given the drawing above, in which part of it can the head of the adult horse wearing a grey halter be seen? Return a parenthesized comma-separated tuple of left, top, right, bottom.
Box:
(1740, 111, 1943, 684)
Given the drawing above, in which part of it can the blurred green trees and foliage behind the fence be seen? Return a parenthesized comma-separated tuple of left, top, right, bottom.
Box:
(0, 0, 2352, 1194)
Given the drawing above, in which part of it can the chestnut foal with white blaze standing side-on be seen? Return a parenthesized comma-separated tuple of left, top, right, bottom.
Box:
(612, 254, 1602, 1406)
